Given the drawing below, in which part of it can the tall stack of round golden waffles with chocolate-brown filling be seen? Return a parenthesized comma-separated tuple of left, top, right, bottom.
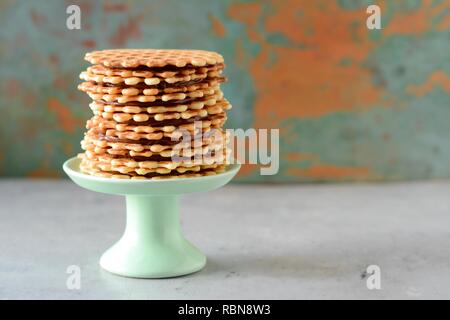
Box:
(78, 49, 231, 179)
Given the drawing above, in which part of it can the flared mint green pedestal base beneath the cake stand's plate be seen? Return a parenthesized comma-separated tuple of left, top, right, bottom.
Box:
(100, 195, 206, 278)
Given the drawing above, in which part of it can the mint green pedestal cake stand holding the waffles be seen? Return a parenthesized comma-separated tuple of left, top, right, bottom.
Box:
(63, 158, 240, 278)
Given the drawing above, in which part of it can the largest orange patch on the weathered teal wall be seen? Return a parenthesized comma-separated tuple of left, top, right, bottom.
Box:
(229, 0, 385, 127)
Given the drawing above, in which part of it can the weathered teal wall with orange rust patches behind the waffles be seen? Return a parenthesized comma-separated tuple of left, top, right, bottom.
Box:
(0, 0, 450, 182)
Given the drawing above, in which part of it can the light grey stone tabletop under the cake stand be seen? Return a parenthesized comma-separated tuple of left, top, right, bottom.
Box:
(0, 179, 450, 299)
